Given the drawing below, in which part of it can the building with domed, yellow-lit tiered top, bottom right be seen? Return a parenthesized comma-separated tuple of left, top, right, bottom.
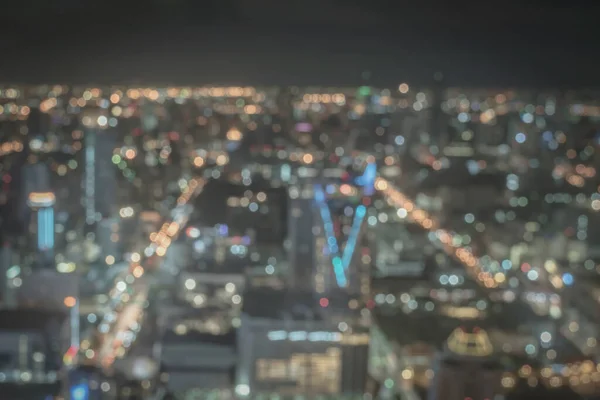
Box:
(429, 328, 502, 400)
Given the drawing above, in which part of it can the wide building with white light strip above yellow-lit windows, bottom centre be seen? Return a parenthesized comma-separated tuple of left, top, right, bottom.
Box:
(236, 291, 369, 398)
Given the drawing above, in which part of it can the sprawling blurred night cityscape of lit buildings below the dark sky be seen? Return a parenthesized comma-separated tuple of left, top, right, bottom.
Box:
(0, 83, 600, 400)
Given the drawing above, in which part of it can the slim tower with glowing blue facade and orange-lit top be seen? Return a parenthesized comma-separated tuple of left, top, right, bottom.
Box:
(27, 192, 56, 267)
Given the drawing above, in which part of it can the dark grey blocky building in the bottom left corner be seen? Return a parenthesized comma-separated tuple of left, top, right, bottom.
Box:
(0, 266, 80, 398)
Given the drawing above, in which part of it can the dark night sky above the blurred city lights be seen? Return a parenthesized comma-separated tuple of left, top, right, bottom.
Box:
(0, 0, 600, 86)
